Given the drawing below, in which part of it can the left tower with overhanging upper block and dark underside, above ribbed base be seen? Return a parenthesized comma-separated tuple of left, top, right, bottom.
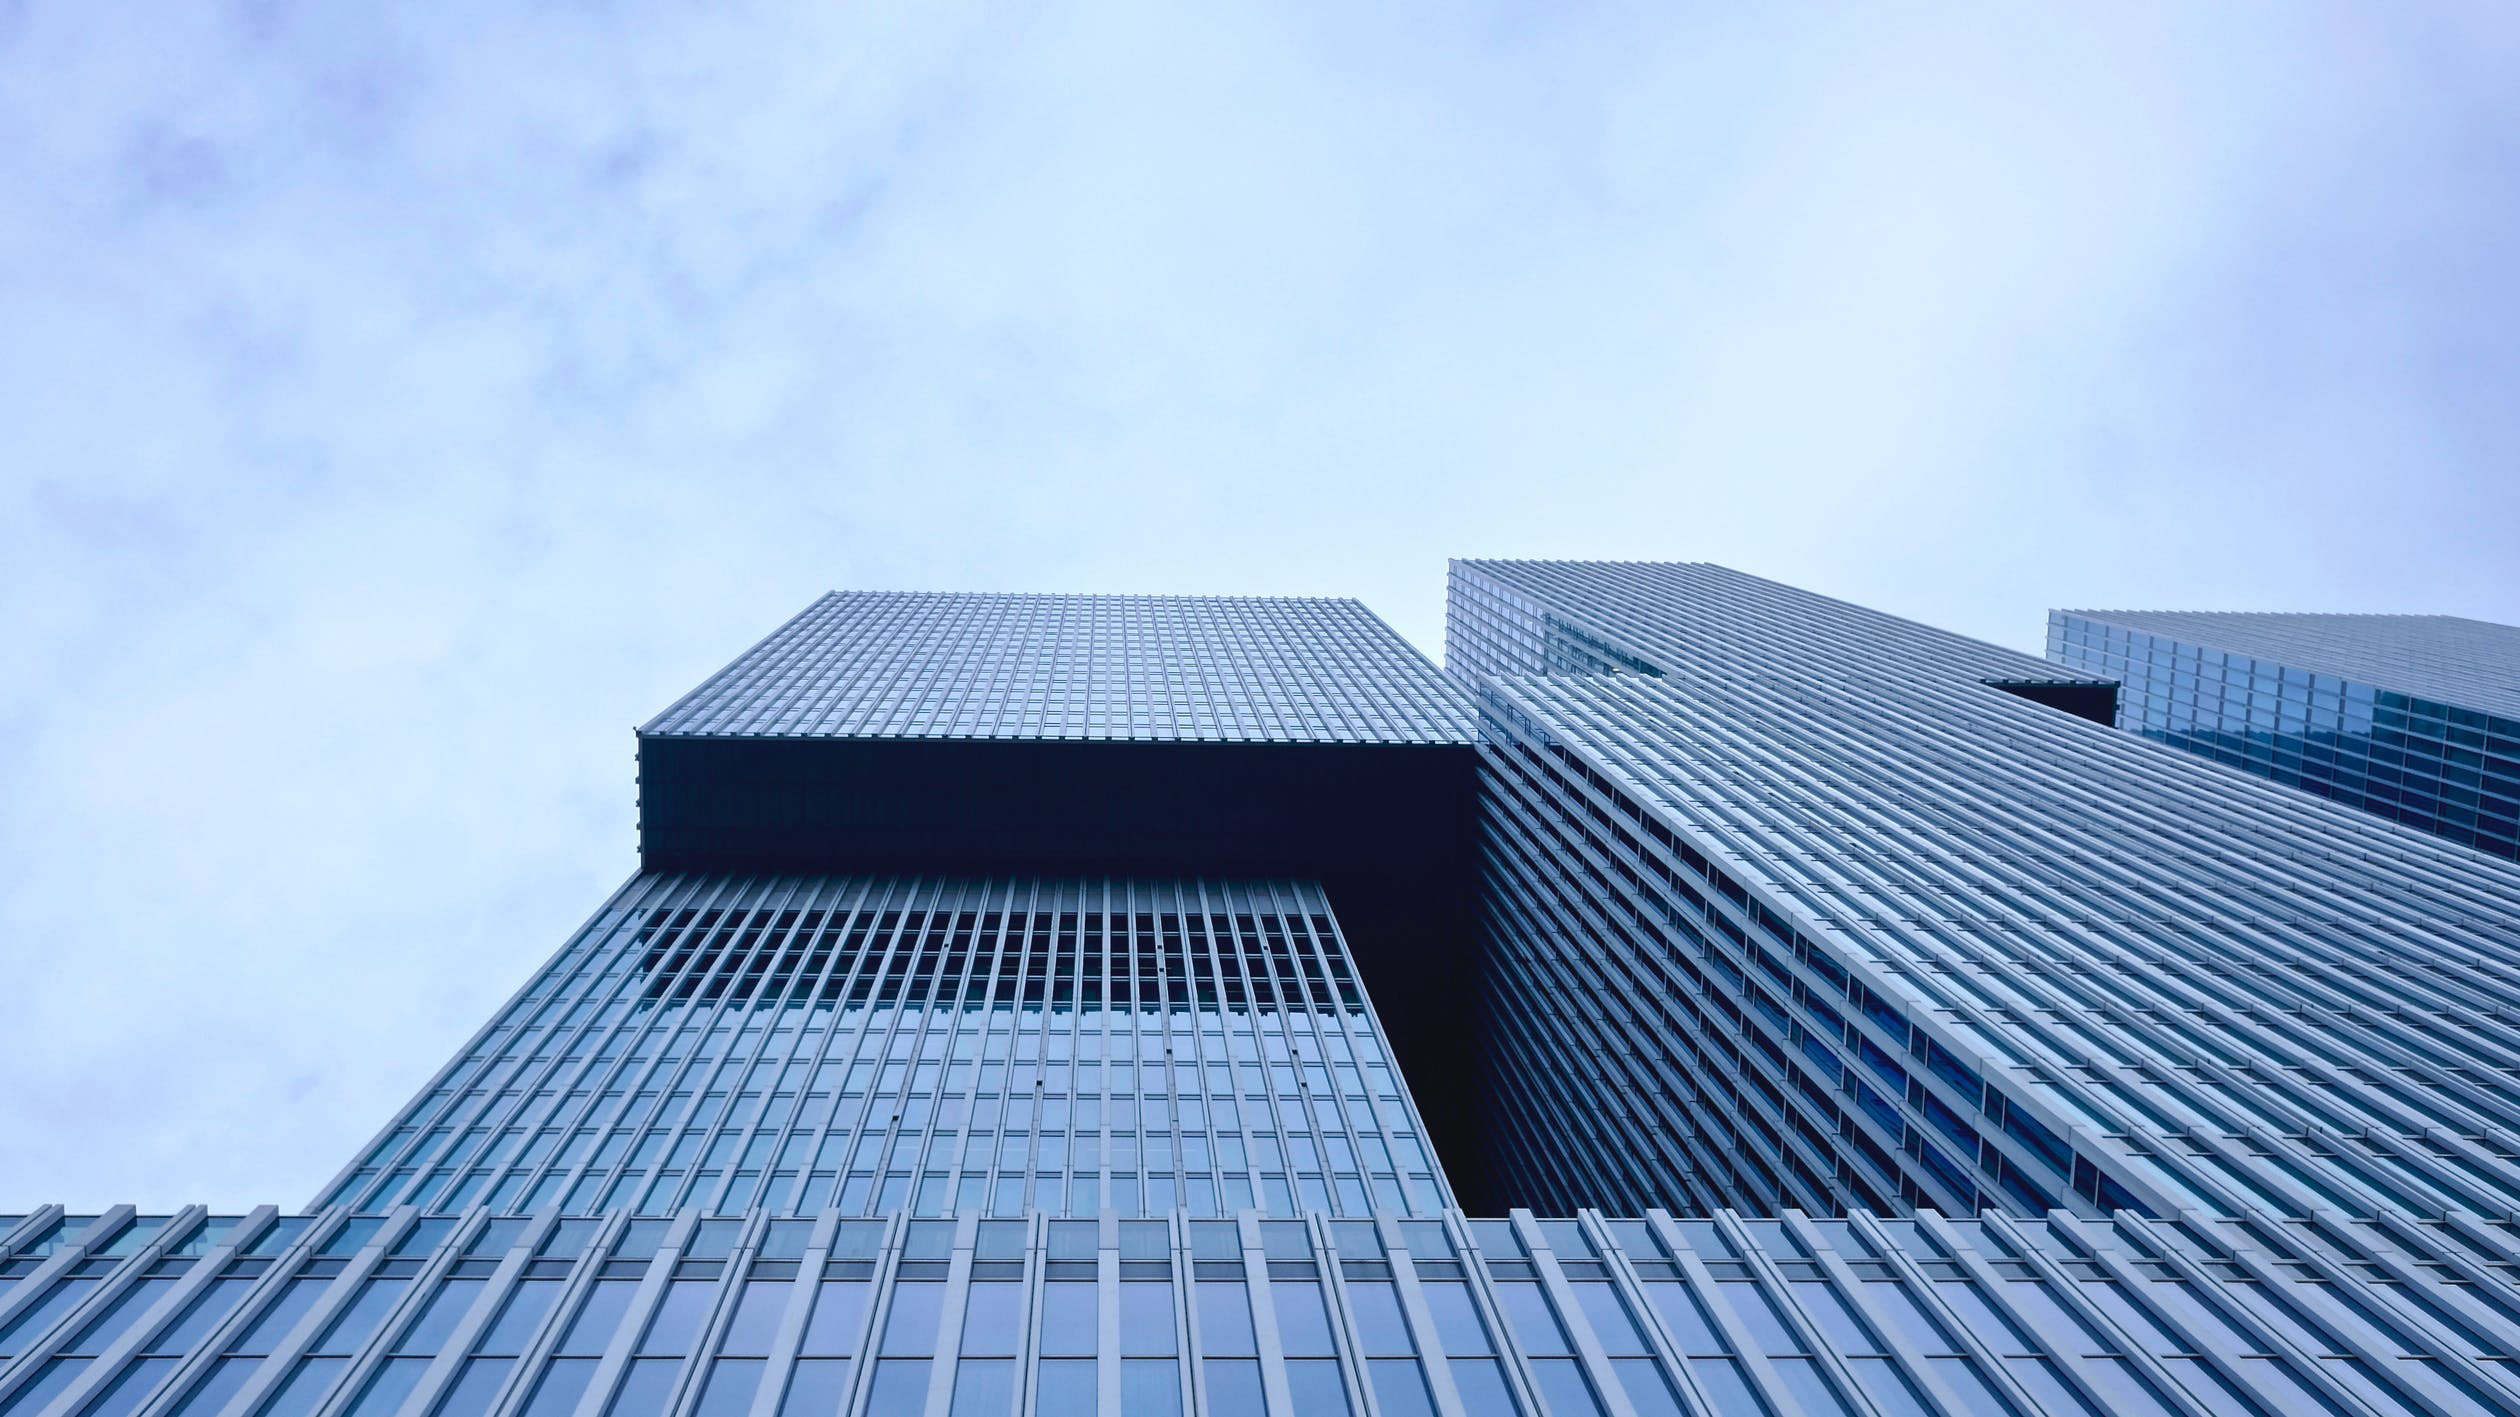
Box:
(325, 595, 1469, 1215)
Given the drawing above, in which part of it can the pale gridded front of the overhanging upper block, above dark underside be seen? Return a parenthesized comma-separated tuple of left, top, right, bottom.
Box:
(640, 590, 1469, 744)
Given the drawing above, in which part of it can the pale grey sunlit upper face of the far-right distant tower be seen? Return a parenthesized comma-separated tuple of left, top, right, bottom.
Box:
(2049, 610, 2520, 721)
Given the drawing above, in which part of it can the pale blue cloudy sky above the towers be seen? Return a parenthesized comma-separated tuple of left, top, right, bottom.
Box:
(0, 0, 2520, 1213)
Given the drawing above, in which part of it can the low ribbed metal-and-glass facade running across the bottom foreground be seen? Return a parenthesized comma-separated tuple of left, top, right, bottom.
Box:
(0, 1208, 2520, 1417)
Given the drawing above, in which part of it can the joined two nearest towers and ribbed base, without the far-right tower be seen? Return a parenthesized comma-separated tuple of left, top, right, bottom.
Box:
(0, 562, 2520, 1417)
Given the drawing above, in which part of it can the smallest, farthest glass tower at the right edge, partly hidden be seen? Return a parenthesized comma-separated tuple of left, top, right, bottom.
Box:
(2049, 610, 2520, 860)
